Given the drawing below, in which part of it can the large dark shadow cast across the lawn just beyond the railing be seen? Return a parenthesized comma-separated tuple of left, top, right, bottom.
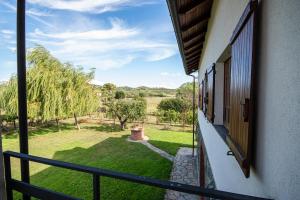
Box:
(16, 135, 172, 200)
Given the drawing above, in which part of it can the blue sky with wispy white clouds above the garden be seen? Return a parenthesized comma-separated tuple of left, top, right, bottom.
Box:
(0, 0, 191, 88)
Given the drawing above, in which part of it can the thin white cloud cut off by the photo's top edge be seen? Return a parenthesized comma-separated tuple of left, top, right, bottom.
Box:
(28, 0, 154, 13)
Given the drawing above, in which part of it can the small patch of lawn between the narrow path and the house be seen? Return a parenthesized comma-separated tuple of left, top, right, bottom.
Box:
(145, 126, 193, 155)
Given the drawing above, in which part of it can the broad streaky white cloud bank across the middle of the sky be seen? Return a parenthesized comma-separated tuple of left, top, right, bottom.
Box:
(28, 18, 177, 70)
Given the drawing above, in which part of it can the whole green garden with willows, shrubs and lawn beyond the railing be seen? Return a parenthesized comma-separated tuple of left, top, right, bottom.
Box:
(0, 46, 196, 199)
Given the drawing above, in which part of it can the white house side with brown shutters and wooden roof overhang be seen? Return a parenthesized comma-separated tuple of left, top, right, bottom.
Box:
(168, 0, 300, 200)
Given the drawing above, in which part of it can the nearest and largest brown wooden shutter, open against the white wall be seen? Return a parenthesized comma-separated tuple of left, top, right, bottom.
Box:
(227, 0, 257, 177)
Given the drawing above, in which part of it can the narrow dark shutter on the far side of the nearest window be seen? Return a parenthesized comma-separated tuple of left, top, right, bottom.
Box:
(206, 64, 216, 123)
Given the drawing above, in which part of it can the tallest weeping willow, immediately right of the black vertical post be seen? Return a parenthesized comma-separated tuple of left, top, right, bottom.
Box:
(27, 46, 65, 125)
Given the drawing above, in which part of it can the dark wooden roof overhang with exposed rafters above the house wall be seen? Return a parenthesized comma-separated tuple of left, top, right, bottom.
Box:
(167, 0, 213, 74)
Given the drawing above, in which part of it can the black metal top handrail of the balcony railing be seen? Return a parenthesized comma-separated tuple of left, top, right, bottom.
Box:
(3, 151, 272, 200)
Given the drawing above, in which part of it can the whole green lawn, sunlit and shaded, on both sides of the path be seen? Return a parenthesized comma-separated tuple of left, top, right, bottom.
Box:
(2, 124, 191, 200)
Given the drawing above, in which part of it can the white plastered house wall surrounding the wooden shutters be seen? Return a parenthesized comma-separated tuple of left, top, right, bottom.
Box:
(198, 0, 300, 200)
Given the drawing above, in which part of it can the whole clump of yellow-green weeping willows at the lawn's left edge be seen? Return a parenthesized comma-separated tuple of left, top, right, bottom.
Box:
(0, 46, 99, 128)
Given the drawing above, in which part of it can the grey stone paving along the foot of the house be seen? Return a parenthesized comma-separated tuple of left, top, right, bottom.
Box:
(165, 147, 199, 200)
